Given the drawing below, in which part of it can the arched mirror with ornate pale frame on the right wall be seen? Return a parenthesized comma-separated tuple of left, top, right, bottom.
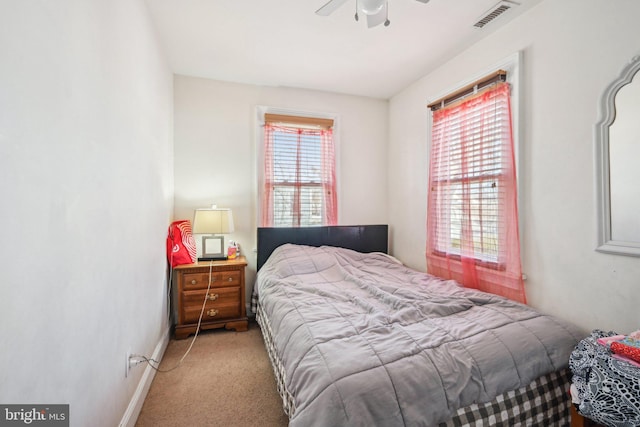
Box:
(594, 56, 640, 256)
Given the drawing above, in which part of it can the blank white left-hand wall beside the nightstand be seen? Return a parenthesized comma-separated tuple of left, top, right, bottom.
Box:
(0, 0, 173, 426)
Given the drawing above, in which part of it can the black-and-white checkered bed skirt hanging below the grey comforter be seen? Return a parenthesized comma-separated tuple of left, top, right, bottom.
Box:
(252, 298, 571, 427)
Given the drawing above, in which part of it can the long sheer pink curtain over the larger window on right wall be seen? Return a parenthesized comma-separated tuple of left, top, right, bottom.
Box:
(427, 83, 526, 303)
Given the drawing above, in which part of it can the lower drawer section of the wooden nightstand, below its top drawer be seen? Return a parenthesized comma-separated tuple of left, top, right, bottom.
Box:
(182, 287, 241, 323)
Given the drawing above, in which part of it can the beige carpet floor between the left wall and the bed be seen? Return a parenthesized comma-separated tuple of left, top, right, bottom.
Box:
(136, 323, 288, 427)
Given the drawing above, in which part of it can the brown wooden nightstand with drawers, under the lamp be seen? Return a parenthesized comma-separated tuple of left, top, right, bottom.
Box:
(173, 257, 249, 339)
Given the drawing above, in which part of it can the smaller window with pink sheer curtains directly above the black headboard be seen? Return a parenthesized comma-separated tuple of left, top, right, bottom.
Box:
(261, 114, 337, 227)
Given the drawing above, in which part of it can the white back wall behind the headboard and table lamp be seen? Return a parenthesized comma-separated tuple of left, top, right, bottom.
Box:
(174, 76, 388, 301)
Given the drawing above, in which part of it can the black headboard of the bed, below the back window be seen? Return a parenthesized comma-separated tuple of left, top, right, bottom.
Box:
(257, 224, 389, 270)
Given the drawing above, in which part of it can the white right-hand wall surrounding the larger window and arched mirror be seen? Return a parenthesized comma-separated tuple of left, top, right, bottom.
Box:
(388, 0, 640, 333)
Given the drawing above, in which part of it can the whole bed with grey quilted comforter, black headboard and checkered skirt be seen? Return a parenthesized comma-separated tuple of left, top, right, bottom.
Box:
(252, 225, 581, 427)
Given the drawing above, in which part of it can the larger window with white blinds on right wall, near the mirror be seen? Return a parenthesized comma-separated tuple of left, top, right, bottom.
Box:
(430, 82, 512, 263)
